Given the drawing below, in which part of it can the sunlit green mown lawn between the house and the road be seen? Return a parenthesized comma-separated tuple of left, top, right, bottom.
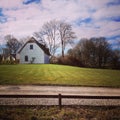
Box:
(0, 64, 120, 87)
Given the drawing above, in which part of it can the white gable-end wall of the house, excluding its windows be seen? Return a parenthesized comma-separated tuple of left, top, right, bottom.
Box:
(20, 43, 44, 63)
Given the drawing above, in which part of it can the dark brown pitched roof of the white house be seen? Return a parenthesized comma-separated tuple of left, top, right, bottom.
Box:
(18, 37, 50, 55)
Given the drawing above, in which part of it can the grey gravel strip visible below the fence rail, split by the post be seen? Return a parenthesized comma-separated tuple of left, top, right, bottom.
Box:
(0, 98, 120, 106)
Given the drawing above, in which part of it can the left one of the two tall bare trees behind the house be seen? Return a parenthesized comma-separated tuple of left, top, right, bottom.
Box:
(34, 20, 59, 56)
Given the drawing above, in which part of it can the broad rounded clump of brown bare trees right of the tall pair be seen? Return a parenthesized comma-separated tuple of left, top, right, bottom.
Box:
(68, 37, 111, 68)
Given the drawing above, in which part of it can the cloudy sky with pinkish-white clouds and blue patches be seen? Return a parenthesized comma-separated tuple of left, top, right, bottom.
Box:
(0, 0, 120, 47)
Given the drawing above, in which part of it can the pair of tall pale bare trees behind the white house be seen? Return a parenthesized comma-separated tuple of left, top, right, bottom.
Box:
(34, 20, 76, 57)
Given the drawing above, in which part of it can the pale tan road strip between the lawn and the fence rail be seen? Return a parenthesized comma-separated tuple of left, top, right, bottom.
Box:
(0, 85, 120, 96)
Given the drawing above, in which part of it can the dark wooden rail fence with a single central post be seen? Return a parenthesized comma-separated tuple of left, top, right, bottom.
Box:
(0, 94, 120, 109)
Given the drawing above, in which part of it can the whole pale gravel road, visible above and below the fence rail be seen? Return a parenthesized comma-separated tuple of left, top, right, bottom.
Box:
(0, 85, 120, 106)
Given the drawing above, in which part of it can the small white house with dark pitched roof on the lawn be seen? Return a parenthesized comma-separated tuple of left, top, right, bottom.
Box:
(18, 37, 50, 64)
